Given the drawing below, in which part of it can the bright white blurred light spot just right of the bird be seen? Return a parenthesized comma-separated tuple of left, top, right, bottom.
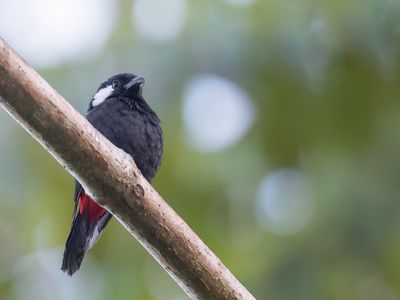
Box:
(183, 75, 255, 152)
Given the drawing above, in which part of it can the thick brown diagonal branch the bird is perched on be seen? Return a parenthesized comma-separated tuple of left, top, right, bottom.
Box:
(0, 38, 254, 299)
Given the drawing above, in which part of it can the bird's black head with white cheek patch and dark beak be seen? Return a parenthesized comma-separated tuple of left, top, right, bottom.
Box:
(89, 73, 144, 110)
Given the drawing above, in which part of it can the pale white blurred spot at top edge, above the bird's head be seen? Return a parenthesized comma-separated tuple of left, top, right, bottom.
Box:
(132, 0, 187, 41)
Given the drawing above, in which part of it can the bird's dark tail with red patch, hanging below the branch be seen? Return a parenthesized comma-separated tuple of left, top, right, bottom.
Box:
(61, 193, 111, 276)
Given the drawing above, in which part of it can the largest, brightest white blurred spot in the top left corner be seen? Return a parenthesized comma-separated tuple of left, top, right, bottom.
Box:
(0, 0, 117, 67)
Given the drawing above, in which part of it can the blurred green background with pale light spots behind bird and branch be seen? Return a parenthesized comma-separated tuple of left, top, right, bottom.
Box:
(0, 0, 400, 300)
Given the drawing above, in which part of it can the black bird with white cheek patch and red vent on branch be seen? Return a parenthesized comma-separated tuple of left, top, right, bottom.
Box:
(61, 73, 163, 276)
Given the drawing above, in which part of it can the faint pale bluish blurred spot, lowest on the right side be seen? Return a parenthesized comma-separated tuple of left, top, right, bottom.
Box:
(256, 169, 314, 235)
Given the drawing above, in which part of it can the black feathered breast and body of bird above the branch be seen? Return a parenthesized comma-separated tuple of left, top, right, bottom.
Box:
(87, 98, 163, 181)
